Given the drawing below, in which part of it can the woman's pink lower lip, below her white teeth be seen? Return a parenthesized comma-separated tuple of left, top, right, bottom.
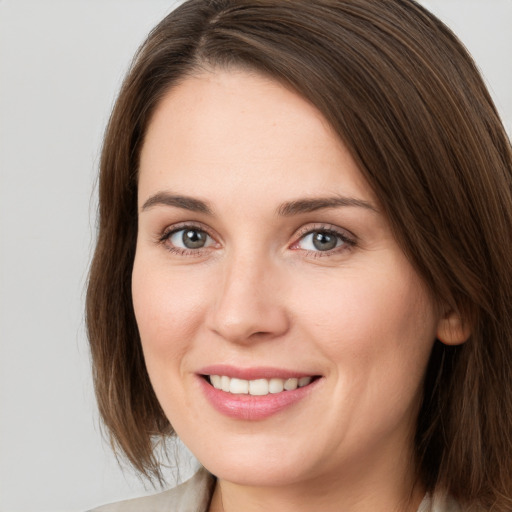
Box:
(198, 377, 321, 421)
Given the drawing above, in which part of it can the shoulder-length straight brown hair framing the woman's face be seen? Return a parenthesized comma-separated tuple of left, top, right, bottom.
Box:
(87, 0, 512, 511)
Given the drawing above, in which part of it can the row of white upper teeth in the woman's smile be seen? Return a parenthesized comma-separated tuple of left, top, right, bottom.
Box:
(210, 375, 313, 396)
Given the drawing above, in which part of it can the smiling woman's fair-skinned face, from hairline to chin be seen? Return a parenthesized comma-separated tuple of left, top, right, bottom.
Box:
(132, 71, 438, 486)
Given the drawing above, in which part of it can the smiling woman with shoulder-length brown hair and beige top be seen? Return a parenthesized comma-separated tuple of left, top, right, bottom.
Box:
(87, 0, 512, 512)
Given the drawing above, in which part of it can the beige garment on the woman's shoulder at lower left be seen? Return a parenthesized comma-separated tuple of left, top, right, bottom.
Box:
(90, 469, 215, 512)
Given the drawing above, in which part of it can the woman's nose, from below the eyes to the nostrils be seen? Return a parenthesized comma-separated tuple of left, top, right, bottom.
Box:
(207, 251, 289, 343)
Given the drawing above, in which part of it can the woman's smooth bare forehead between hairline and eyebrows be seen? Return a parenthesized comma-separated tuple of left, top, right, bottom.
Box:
(139, 70, 371, 208)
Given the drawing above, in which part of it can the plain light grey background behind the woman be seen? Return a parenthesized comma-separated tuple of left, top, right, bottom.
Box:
(0, 0, 512, 512)
